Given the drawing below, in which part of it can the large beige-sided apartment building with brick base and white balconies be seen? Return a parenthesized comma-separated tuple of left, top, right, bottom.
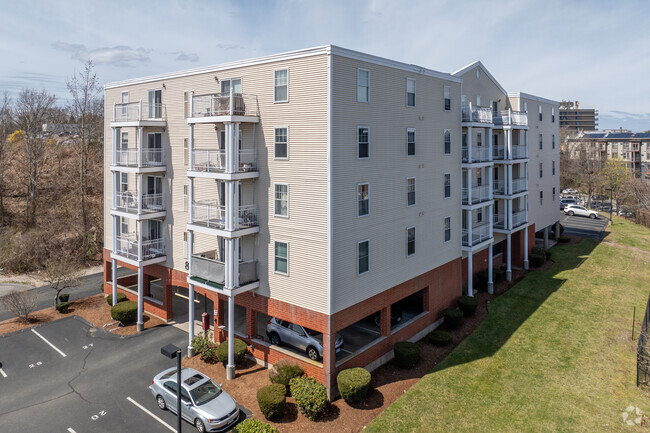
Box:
(104, 46, 559, 389)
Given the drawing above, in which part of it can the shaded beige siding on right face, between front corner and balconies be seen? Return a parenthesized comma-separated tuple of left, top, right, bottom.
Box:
(332, 56, 460, 312)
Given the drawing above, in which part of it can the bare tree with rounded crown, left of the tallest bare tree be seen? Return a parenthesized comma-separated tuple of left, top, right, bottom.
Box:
(15, 89, 56, 225)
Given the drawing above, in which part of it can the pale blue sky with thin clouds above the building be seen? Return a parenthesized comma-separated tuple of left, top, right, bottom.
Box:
(0, 0, 650, 131)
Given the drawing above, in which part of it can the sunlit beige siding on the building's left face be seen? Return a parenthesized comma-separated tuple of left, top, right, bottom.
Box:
(105, 54, 328, 312)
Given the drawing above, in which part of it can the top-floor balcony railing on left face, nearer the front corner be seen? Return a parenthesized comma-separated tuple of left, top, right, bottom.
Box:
(190, 93, 259, 117)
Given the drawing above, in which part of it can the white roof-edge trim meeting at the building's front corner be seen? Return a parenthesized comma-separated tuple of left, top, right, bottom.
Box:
(104, 45, 462, 90)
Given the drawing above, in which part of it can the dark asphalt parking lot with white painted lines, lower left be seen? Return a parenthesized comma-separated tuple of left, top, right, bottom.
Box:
(0, 317, 247, 433)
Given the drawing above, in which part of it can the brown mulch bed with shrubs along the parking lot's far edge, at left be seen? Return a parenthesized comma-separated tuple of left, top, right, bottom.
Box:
(0, 294, 165, 335)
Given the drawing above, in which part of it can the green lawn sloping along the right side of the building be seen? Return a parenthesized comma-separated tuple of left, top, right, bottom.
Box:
(364, 219, 650, 433)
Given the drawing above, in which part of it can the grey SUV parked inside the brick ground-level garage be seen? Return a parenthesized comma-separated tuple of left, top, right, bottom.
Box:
(266, 317, 343, 361)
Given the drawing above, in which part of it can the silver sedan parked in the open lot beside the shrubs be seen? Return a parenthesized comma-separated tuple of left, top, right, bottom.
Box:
(151, 367, 239, 433)
